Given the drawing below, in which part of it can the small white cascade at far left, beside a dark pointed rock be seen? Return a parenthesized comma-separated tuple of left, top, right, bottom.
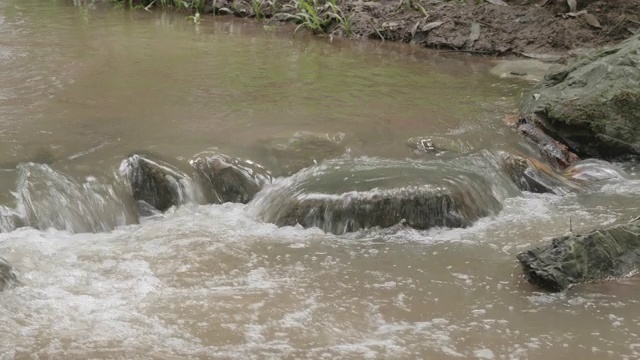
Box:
(14, 163, 137, 232)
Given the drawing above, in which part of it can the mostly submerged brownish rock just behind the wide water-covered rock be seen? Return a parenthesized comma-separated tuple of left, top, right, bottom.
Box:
(260, 131, 347, 176)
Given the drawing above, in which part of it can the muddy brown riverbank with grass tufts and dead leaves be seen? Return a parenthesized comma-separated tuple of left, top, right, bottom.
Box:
(120, 0, 640, 61)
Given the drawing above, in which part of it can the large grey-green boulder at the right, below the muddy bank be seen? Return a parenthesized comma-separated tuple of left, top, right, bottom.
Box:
(521, 35, 640, 159)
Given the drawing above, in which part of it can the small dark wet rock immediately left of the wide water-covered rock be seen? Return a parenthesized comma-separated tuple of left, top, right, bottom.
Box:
(191, 154, 271, 204)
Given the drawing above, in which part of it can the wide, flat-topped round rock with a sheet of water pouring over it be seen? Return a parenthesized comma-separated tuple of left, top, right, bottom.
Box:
(251, 159, 501, 234)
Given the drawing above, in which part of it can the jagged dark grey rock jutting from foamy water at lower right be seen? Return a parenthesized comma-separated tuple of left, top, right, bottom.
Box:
(517, 222, 640, 291)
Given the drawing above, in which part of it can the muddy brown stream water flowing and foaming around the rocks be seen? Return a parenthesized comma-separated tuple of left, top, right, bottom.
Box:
(0, 0, 640, 359)
